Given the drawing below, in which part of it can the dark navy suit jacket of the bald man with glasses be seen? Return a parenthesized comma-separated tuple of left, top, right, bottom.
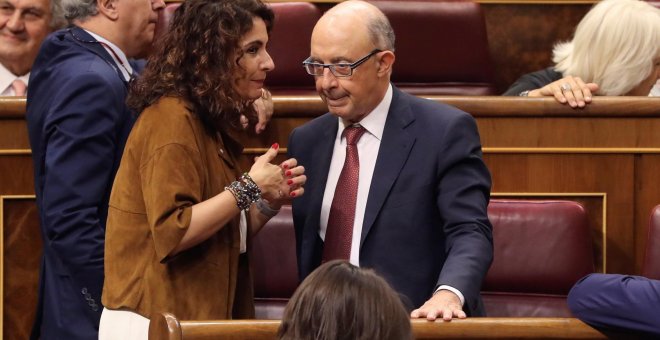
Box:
(288, 88, 493, 316)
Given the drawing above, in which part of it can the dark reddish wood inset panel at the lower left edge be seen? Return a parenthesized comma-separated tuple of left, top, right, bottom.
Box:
(0, 196, 42, 340)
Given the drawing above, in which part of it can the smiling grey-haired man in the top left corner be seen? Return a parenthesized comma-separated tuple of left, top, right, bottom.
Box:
(0, 0, 66, 96)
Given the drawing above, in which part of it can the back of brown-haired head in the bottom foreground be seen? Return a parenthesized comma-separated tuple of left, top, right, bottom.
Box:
(277, 260, 413, 340)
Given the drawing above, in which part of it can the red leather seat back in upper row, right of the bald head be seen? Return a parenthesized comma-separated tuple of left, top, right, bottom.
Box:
(371, 1, 496, 95)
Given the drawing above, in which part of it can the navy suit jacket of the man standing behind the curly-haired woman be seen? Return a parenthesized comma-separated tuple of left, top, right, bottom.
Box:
(26, 27, 134, 339)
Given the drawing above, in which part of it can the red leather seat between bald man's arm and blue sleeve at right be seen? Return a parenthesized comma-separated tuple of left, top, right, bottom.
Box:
(482, 200, 595, 317)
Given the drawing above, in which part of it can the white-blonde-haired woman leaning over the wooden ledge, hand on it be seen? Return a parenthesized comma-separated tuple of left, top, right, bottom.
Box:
(504, 0, 660, 108)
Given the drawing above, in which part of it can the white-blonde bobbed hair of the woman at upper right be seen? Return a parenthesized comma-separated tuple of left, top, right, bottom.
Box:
(553, 0, 660, 96)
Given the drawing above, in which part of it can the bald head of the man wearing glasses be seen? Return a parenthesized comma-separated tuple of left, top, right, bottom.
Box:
(309, 1, 395, 123)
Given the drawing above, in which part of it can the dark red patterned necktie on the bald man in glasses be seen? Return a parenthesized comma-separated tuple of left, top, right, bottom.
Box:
(323, 126, 366, 262)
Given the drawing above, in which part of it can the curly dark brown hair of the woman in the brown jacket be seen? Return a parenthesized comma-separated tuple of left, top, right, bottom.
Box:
(127, 0, 274, 133)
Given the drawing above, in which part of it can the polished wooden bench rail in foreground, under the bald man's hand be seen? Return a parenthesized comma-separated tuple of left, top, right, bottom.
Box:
(149, 313, 616, 340)
